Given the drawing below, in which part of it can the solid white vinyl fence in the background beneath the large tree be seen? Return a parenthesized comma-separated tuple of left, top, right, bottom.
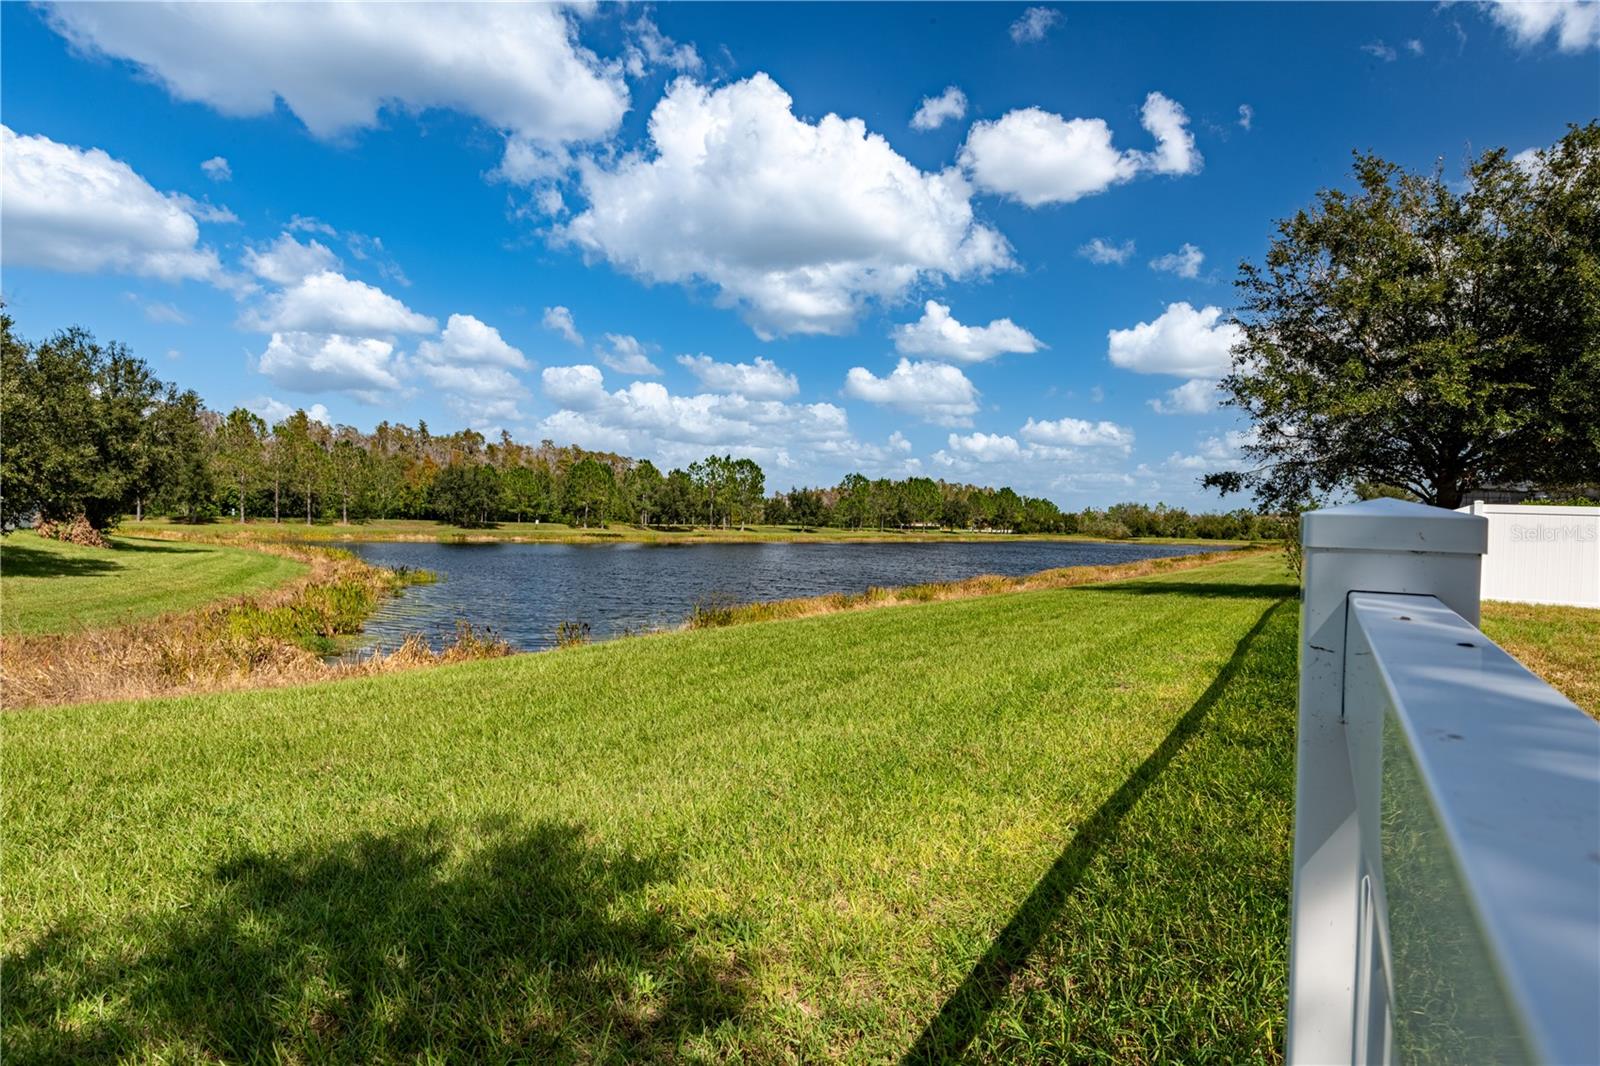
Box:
(1461, 503, 1600, 608)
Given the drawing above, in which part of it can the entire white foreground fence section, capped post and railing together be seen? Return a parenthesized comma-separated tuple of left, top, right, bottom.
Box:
(1288, 499, 1600, 1064)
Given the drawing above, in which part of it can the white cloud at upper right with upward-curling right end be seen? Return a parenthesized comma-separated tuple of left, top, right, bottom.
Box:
(960, 93, 1202, 206)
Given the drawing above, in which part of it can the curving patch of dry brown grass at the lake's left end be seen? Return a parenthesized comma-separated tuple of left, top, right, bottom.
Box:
(0, 544, 510, 711)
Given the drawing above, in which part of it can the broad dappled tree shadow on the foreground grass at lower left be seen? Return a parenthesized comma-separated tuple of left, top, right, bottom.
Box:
(3, 823, 746, 1061)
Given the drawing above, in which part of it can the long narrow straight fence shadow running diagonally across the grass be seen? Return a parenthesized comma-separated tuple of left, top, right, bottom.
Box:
(901, 601, 1283, 1064)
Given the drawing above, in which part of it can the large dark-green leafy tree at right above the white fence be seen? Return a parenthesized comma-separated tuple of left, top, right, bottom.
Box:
(1205, 123, 1600, 507)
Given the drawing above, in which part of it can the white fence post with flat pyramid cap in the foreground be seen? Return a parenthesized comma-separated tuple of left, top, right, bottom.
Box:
(1286, 499, 1488, 1063)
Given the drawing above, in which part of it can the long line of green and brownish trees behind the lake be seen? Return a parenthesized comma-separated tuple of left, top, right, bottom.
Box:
(0, 312, 1278, 538)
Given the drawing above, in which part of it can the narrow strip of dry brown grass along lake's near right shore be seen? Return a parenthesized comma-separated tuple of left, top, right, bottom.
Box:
(688, 546, 1288, 629)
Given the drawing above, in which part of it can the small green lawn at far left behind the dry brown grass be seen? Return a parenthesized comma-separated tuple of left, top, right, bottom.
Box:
(0, 531, 306, 634)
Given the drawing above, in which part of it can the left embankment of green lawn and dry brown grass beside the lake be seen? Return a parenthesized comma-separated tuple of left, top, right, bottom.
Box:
(0, 533, 489, 709)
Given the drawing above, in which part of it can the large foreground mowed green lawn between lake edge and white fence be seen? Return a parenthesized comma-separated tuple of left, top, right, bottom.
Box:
(0, 555, 1296, 1063)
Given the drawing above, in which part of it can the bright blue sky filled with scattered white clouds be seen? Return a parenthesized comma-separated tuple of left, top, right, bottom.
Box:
(0, 2, 1600, 507)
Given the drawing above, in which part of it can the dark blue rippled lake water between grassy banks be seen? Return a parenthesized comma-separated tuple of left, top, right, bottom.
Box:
(344, 539, 1214, 650)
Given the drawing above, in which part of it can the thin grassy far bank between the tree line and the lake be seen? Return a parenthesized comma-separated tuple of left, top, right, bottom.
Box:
(122, 519, 1251, 547)
